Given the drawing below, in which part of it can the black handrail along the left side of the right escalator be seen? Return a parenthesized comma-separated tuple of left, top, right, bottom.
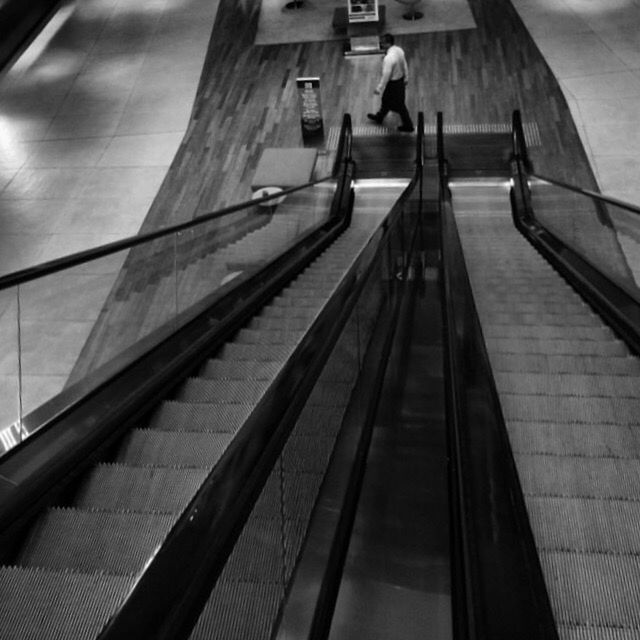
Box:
(438, 112, 558, 640)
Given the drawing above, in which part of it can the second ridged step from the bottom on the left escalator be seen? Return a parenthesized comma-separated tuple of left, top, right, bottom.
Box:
(16, 509, 177, 575)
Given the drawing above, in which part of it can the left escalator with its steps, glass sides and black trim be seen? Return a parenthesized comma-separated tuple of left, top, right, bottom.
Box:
(0, 116, 420, 639)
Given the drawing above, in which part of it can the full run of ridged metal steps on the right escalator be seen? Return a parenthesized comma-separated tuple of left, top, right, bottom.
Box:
(451, 181, 640, 640)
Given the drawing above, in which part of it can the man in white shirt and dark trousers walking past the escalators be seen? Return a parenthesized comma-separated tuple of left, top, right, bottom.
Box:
(367, 33, 413, 132)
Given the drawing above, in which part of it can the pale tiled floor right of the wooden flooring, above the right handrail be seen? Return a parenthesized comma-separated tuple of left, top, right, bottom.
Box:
(512, 0, 640, 204)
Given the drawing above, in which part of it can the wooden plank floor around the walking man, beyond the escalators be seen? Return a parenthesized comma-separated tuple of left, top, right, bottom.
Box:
(145, 0, 596, 229)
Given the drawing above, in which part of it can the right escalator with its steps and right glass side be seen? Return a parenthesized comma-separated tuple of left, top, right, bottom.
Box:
(445, 112, 640, 638)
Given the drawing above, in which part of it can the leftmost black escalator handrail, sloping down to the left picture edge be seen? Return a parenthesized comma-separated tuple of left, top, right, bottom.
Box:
(0, 121, 351, 291)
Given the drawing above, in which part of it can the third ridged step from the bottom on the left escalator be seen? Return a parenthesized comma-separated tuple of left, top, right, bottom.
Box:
(74, 464, 207, 513)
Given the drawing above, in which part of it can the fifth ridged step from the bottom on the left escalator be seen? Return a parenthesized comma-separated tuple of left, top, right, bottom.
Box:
(148, 400, 252, 433)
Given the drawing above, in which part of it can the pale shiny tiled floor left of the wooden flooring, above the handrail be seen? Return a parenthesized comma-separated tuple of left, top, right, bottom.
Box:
(0, 0, 217, 274)
